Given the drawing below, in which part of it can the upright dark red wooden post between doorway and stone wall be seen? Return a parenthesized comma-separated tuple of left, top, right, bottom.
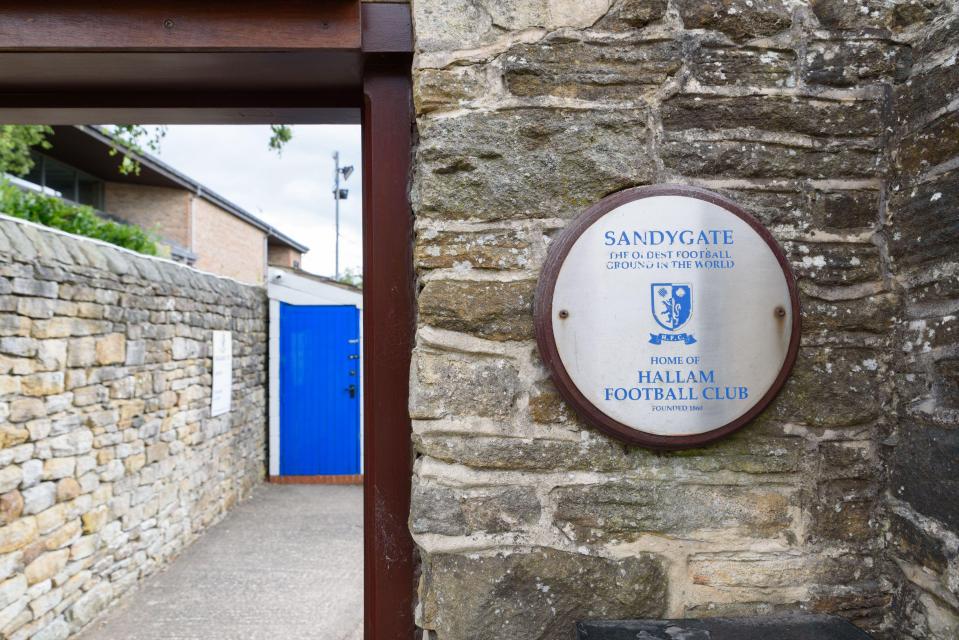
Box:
(363, 63, 415, 640)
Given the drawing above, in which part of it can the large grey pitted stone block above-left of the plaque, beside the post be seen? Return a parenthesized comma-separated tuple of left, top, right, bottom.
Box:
(413, 108, 654, 220)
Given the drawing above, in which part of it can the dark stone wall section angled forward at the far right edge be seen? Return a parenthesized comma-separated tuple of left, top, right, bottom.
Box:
(884, 7, 959, 638)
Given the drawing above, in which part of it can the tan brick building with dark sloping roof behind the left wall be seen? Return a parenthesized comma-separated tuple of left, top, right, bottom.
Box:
(17, 126, 309, 284)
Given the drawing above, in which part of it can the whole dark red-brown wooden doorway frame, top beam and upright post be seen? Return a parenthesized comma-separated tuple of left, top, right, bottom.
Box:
(0, 0, 415, 640)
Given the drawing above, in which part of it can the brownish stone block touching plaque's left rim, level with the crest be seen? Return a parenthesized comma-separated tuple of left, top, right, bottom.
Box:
(419, 280, 536, 340)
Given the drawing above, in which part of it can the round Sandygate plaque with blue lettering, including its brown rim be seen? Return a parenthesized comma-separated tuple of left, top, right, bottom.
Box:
(534, 185, 799, 449)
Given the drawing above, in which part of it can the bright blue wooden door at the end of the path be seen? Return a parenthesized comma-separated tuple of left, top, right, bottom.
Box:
(280, 303, 360, 476)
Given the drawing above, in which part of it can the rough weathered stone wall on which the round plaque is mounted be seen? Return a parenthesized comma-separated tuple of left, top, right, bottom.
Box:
(410, 0, 959, 640)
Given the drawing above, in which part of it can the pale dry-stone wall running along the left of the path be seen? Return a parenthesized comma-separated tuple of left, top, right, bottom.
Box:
(0, 217, 267, 640)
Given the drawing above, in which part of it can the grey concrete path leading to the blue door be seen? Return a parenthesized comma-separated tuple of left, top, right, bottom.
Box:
(79, 484, 363, 640)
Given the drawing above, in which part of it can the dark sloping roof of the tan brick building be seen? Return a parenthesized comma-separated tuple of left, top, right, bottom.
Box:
(43, 125, 310, 253)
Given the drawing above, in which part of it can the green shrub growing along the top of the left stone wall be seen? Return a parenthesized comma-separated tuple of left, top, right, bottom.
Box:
(0, 182, 157, 256)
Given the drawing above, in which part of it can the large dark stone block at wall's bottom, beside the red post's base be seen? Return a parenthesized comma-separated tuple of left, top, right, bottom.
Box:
(422, 548, 666, 640)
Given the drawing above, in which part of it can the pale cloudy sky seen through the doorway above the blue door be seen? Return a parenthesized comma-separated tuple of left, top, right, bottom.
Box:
(156, 125, 362, 275)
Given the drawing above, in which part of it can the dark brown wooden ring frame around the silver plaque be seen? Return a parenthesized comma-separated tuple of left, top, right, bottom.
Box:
(533, 184, 801, 450)
